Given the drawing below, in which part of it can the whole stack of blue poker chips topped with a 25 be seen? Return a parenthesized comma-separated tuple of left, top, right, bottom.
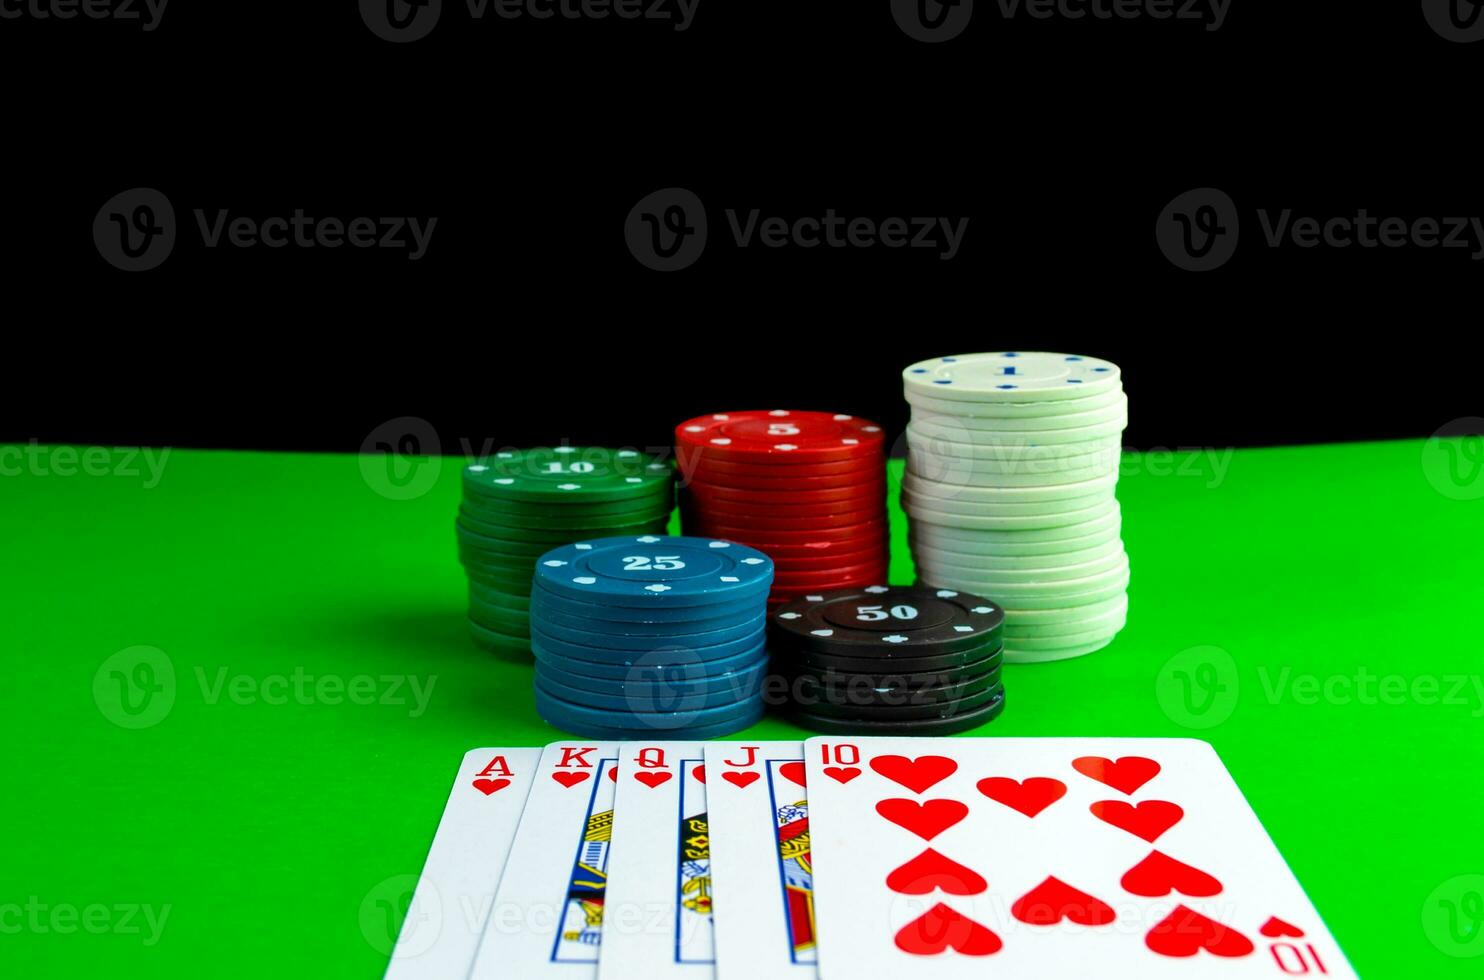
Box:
(530, 535, 773, 739)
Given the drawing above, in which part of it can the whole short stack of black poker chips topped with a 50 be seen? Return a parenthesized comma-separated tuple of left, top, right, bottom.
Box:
(769, 585, 1005, 735)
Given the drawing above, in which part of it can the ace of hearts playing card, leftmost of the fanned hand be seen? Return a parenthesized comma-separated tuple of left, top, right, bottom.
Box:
(386, 748, 542, 980)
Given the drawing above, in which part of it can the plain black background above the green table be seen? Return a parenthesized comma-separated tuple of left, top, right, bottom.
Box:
(0, 0, 1484, 451)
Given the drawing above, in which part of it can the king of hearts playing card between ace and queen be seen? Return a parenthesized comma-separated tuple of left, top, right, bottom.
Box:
(469, 742, 619, 980)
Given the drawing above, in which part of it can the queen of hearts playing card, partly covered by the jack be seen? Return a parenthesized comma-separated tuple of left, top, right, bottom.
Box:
(598, 742, 714, 980)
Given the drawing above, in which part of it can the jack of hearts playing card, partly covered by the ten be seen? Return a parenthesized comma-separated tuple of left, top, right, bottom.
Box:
(706, 742, 815, 980)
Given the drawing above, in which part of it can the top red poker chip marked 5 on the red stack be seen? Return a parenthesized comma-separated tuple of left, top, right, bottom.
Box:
(675, 408, 886, 463)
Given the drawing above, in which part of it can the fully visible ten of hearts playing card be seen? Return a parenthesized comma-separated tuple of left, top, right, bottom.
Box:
(807, 736, 1355, 980)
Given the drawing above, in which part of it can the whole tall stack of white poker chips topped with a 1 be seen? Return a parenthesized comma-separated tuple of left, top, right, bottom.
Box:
(902, 350, 1129, 664)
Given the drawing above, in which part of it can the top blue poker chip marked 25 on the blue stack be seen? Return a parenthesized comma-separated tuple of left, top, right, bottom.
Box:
(536, 535, 773, 607)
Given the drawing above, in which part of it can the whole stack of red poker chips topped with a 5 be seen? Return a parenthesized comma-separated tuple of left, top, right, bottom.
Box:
(675, 410, 889, 604)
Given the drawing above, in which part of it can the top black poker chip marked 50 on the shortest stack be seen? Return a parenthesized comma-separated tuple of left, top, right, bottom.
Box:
(769, 585, 1005, 659)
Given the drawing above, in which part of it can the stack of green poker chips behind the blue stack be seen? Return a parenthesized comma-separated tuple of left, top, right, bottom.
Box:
(457, 445, 674, 653)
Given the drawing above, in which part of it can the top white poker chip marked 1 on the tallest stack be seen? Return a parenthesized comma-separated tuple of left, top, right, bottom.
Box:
(902, 350, 1122, 402)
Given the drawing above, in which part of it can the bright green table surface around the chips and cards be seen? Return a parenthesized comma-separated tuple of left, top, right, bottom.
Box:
(0, 441, 1484, 979)
